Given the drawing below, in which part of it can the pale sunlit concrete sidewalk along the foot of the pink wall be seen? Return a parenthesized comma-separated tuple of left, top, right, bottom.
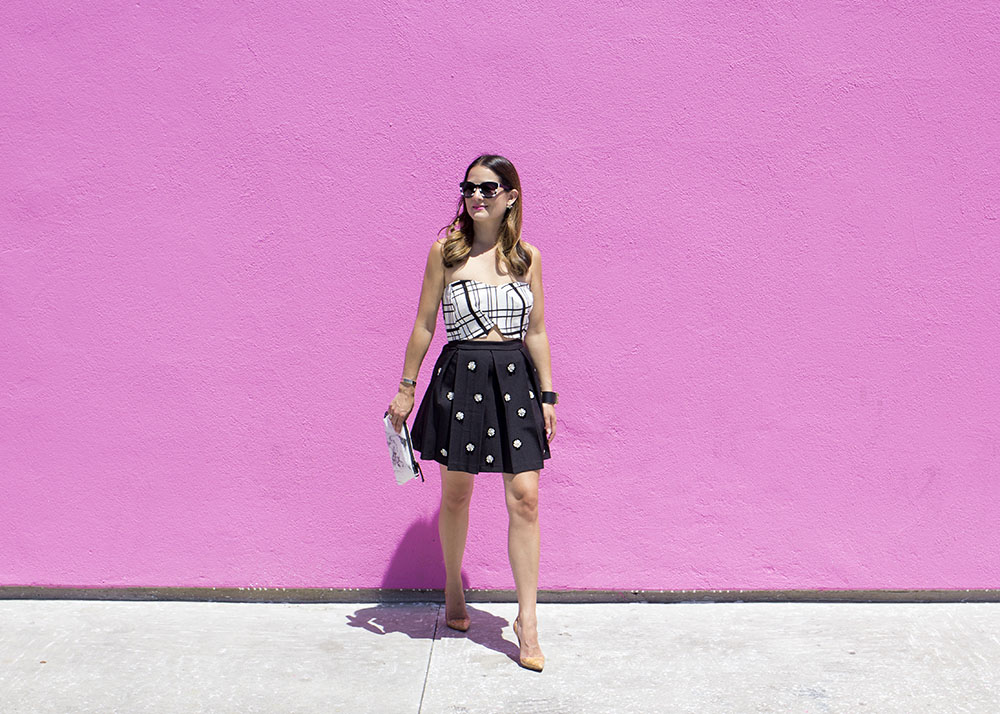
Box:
(0, 600, 1000, 714)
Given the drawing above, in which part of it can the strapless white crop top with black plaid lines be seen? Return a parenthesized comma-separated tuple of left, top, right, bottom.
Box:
(441, 280, 534, 342)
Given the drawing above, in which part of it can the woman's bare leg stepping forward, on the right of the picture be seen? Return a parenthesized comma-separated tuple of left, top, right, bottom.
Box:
(503, 471, 542, 659)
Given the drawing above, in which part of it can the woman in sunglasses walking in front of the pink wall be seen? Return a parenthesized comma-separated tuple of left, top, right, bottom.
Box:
(389, 154, 557, 672)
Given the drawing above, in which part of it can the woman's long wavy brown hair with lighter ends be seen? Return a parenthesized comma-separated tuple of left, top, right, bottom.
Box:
(438, 154, 531, 276)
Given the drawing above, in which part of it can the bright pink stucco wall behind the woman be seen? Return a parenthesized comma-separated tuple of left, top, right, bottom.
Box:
(0, 0, 1000, 589)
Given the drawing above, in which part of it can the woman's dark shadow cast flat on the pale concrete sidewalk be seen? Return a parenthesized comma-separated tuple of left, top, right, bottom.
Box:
(347, 604, 520, 662)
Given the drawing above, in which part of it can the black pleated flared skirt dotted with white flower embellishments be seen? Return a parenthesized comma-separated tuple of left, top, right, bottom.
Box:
(410, 340, 550, 474)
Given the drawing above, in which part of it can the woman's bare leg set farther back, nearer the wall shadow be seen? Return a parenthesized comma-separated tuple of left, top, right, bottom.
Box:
(438, 466, 475, 630)
